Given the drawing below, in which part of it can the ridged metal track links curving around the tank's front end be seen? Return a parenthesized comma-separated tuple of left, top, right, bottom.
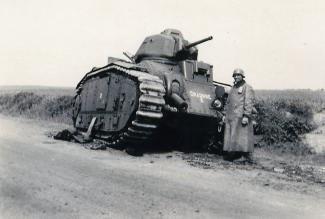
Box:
(81, 62, 166, 148)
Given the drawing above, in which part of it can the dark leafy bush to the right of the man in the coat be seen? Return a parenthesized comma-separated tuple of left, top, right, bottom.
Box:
(255, 99, 316, 145)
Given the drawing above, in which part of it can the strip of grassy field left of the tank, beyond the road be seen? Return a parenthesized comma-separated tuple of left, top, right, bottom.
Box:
(0, 86, 74, 124)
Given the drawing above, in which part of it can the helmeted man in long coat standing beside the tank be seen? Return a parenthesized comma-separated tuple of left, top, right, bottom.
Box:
(223, 68, 255, 163)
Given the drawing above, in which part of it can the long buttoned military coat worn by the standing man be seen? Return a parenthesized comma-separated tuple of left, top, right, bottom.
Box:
(223, 81, 255, 152)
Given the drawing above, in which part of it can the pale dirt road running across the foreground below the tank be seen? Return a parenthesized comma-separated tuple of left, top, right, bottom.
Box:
(0, 116, 325, 218)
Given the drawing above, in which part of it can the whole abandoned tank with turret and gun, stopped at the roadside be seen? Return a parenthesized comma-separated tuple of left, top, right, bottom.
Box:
(73, 29, 226, 151)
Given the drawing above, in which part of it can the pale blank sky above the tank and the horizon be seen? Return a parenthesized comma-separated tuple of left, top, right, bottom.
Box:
(0, 0, 325, 89)
